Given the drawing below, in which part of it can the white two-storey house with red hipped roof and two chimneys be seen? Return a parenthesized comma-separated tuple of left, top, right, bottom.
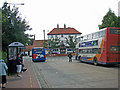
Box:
(47, 24, 81, 54)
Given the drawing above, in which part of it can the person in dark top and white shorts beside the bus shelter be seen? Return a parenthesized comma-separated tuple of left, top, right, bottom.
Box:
(16, 53, 22, 77)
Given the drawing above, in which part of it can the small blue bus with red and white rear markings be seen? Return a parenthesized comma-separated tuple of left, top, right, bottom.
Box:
(32, 47, 46, 62)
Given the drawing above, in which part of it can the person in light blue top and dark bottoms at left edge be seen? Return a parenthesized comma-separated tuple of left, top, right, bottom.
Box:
(0, 60, 8, 88)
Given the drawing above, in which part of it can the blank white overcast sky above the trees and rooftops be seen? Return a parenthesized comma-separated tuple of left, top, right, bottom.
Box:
(0, 0, 119, 40)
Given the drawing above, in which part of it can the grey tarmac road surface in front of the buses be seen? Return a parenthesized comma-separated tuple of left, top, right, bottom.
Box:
(32, 57, 118, 88)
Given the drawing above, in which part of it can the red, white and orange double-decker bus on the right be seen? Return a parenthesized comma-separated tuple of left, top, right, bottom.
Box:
(76, 27, 120, 65)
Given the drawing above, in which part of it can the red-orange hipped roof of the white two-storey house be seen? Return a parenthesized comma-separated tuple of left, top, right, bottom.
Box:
(48, 28, 82, 35)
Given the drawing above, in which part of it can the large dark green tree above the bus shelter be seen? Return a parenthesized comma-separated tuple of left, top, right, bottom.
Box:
(2, 2, 31, 50)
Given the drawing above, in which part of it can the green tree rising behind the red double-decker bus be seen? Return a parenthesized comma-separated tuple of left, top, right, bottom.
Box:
(98, 9, 119, 29)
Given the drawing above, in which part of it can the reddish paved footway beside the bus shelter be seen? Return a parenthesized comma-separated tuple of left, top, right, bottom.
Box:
(6, 57, 40, 88)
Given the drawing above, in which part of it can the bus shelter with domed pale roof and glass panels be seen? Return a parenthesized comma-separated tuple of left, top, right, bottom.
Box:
(7, 42, 25, 75)
